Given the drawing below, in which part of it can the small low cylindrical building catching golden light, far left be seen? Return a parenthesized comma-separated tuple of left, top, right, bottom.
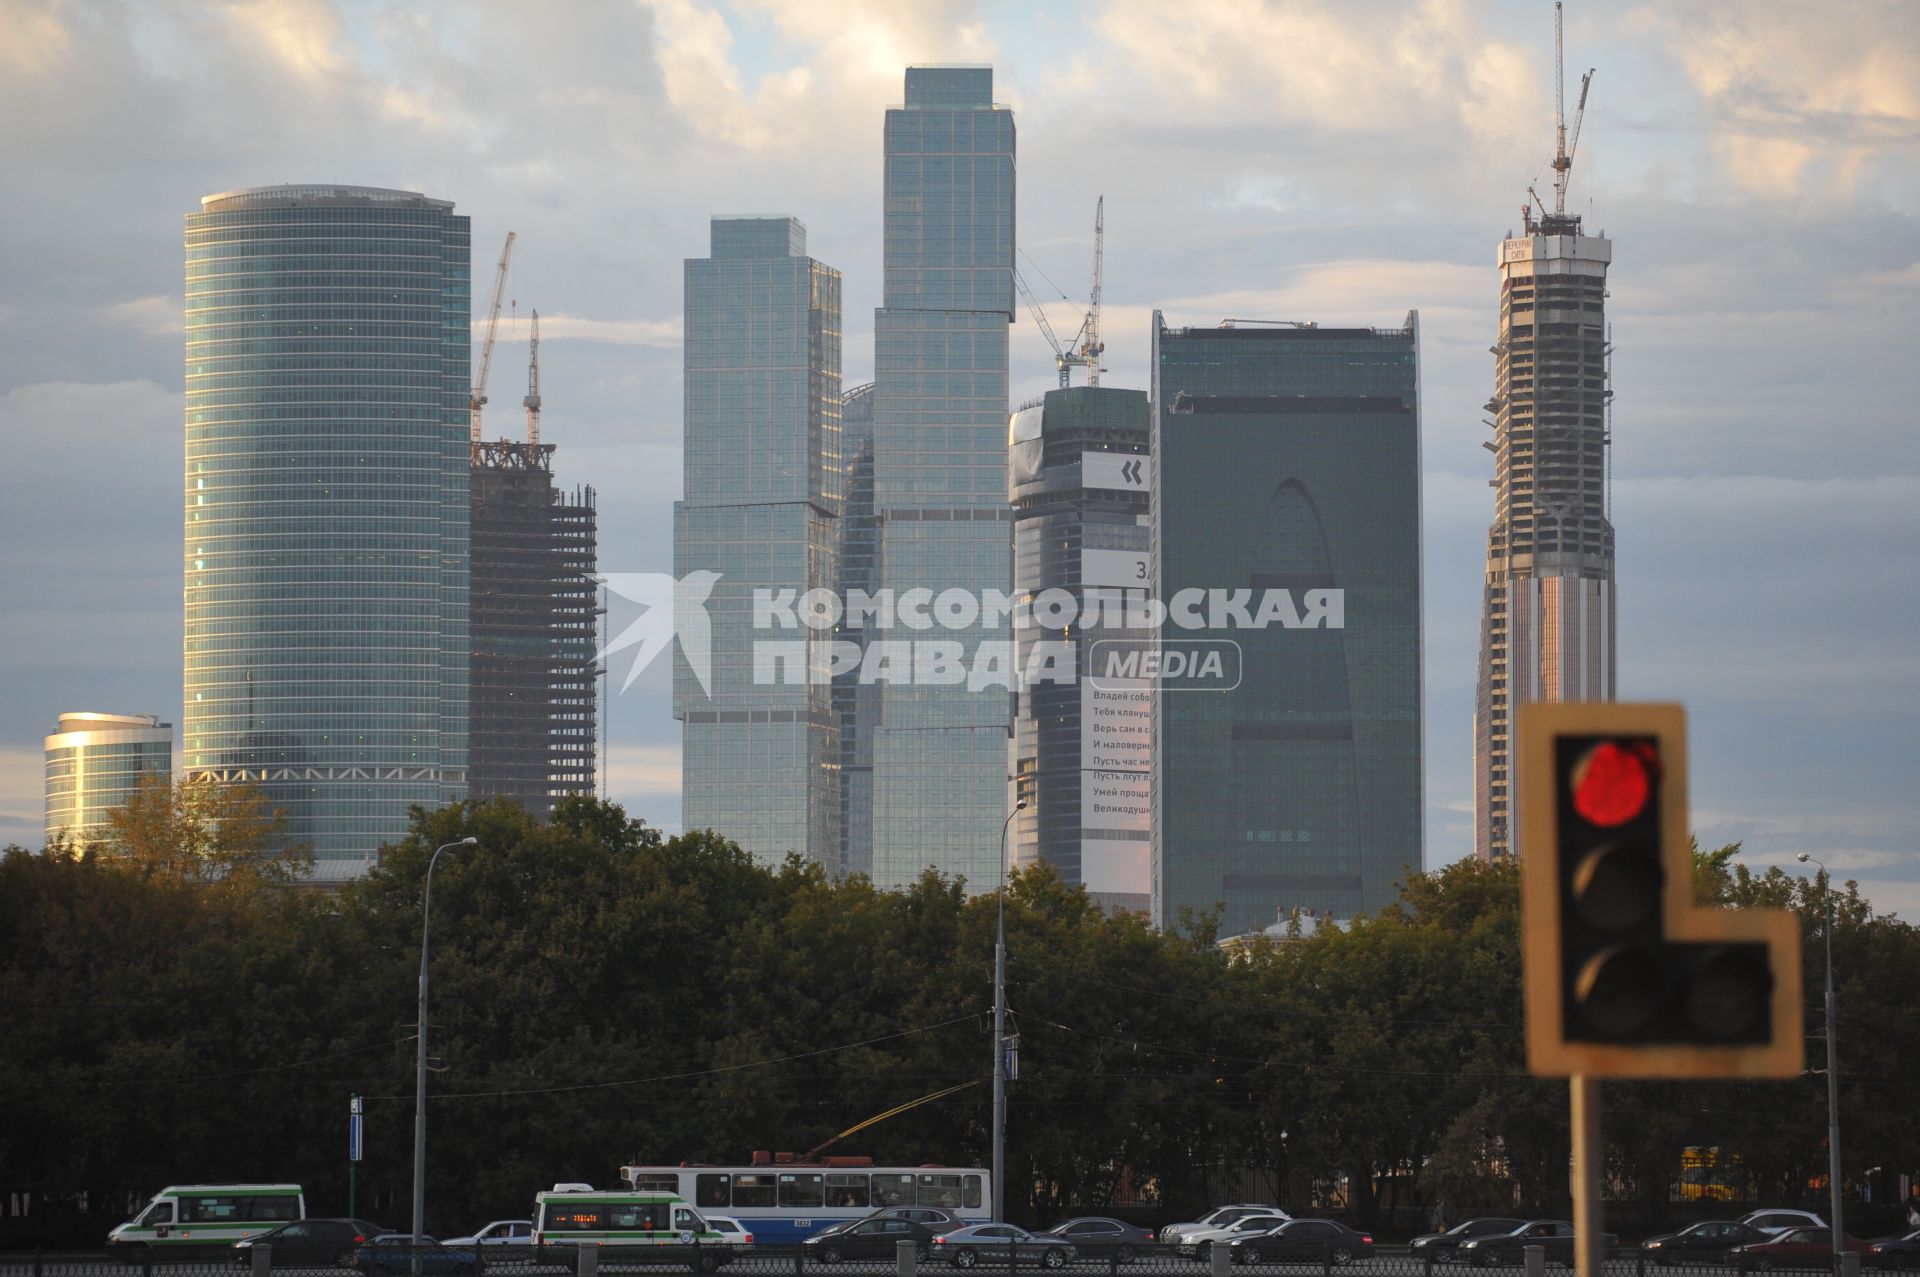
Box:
(46, 714, 173, 847)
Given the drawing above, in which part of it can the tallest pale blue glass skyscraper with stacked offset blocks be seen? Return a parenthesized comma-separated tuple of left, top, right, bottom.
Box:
(872, 67, 1014, 891)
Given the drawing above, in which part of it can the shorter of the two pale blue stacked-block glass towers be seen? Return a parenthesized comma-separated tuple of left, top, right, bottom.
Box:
(674, 217, 841, 872)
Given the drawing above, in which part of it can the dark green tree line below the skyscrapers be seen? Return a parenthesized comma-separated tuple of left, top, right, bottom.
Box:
(0, 785, 1920, 1244)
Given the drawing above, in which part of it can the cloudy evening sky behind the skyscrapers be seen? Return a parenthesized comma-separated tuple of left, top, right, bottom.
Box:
(0, 0, 1920, 920)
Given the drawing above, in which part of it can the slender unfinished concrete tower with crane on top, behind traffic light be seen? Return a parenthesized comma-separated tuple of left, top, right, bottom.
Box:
(1473, 213, 1617, 860)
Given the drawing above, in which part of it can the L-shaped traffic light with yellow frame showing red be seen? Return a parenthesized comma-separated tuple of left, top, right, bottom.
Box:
(1515, 701, 1805, 1077)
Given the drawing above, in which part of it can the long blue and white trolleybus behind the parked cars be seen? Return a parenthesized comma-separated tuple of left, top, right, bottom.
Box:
(620, 1158, 993, 1244)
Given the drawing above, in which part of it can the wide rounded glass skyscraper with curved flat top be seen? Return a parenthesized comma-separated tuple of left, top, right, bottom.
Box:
(182, 186, 470, 881)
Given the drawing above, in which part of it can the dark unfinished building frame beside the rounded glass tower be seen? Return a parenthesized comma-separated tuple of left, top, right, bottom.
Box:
(467, 440, 601, 818)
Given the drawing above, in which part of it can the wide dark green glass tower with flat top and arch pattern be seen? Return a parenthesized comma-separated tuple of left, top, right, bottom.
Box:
(1152, 313, 1425, 933)
